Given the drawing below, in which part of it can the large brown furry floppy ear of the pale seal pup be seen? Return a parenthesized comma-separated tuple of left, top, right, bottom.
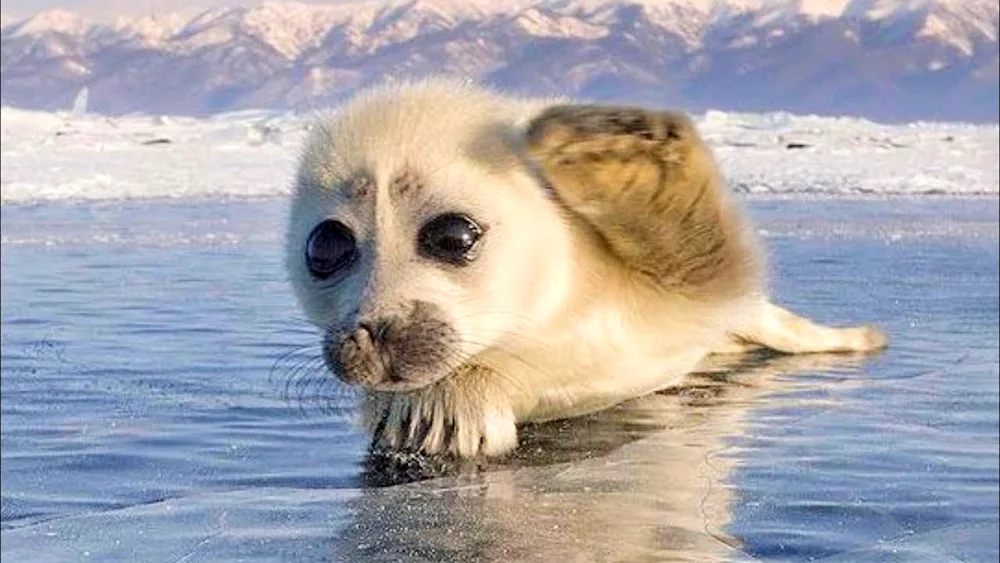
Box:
(525, 105, 757, 297)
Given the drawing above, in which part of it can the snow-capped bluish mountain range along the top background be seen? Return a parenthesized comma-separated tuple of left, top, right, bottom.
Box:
(0, 0, 1000, 122)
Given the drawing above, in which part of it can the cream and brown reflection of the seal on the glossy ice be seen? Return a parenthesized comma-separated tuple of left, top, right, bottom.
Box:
(333, 354, 876, 561)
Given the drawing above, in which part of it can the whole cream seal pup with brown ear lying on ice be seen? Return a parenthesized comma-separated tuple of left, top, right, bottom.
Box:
(286, 79, 886, 457)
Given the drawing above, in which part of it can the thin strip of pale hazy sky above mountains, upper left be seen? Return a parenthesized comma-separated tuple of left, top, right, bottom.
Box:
(3, 0, 360, 20)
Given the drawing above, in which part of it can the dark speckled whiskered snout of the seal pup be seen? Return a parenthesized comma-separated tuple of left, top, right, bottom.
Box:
(323, 302, 457, 391)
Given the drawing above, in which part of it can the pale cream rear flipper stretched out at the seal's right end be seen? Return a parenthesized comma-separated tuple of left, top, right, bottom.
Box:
(715, 302, 889, 354)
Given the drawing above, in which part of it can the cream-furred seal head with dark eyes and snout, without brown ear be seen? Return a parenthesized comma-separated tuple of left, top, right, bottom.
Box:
(286, 80, 571, 391)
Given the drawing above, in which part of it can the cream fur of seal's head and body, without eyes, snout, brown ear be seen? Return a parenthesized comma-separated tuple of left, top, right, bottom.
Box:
(287, 80, 888, 456)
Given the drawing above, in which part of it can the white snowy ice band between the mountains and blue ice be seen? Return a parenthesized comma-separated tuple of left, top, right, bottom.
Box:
(0, 104, 1000, 205)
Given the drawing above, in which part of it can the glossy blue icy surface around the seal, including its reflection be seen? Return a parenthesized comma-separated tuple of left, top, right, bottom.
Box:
(0, 199, 1000, 562)
